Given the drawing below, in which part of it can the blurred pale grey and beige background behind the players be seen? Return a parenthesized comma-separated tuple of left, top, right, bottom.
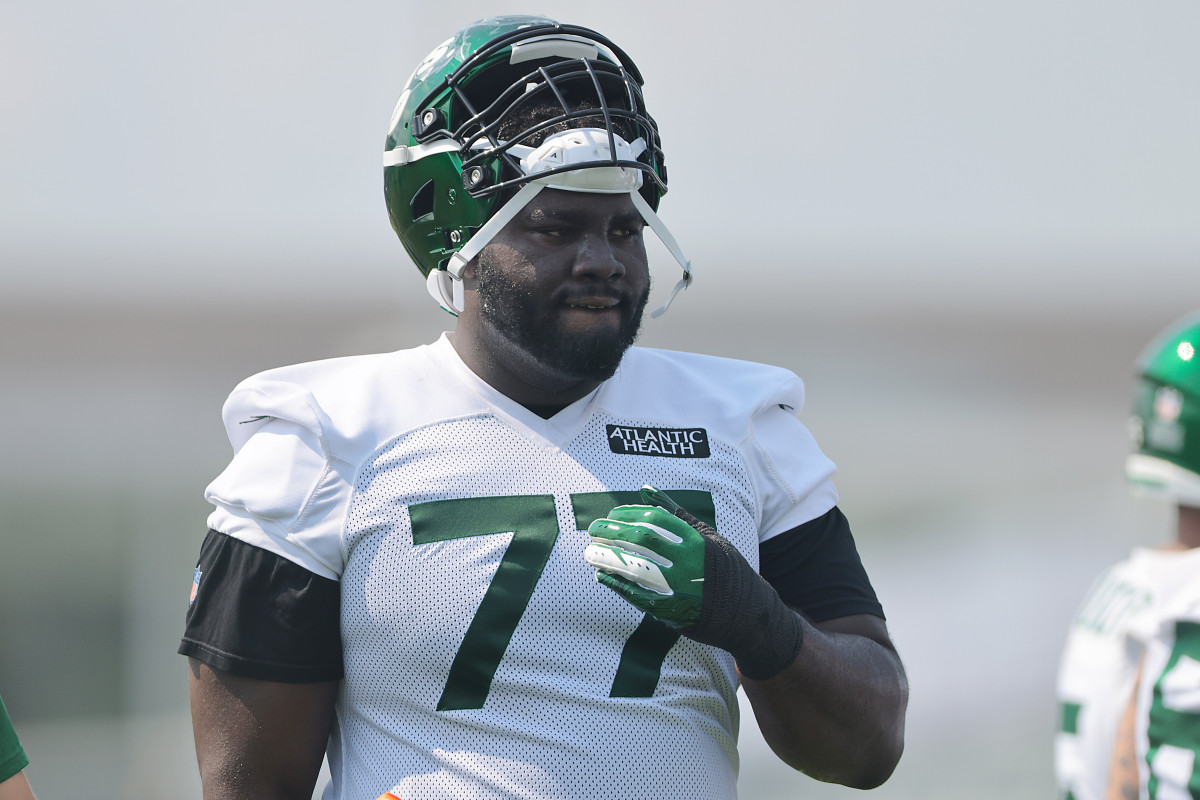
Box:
(0, 0, 1200, 800)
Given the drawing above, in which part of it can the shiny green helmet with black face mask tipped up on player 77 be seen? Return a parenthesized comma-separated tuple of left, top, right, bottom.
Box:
(383, 16, 691, 315)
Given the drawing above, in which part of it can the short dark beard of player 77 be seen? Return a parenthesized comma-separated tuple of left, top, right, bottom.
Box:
(476, 261, 650, 391)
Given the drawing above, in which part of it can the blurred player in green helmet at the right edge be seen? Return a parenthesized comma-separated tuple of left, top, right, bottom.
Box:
(1055, 317, 1200, 800)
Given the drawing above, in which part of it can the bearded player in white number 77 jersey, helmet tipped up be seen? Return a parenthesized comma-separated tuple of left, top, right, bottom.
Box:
(180, 17, 907, 800)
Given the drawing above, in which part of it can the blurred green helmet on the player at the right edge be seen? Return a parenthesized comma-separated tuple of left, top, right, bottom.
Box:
(1126, 313, 1200, 506)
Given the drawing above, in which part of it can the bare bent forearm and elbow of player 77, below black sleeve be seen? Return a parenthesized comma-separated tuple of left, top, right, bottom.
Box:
(742, 614, 908, 789)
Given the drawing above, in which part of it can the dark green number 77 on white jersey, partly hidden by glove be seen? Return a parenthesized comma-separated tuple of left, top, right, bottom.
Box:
(408, 489, 715, 711)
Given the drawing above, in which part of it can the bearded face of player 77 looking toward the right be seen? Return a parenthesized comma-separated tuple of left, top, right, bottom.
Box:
(475, 190, 650, 393)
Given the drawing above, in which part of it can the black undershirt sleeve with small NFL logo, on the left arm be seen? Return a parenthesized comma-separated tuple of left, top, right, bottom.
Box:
(179, 530, 342, 684)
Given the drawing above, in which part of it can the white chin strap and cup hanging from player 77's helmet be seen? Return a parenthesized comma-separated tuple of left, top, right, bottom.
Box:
(426, 128, 692, 318)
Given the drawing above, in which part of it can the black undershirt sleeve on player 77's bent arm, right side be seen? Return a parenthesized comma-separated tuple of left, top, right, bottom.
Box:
(758, 506, 883, 622)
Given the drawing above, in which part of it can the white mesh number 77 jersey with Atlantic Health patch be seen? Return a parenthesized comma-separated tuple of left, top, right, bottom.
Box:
(206, 337, 836, 800)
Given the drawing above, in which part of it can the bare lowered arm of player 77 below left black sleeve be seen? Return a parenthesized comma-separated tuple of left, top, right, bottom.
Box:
(188, 658, 338, 800)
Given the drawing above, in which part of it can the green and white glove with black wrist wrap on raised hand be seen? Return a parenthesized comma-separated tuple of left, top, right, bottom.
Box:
(583, 486, 803, 680)
